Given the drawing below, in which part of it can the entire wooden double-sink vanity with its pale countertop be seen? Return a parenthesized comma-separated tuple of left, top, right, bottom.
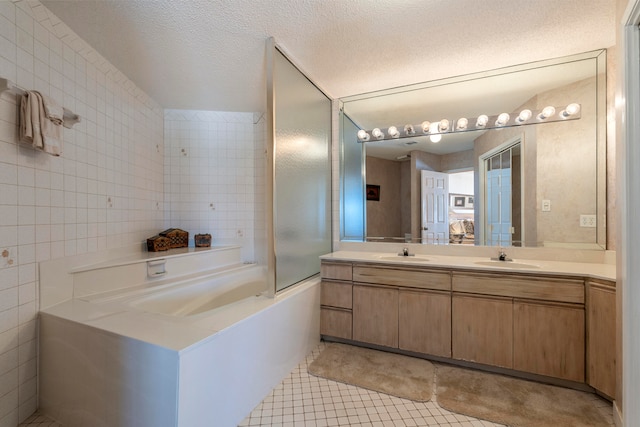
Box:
(320, 252, 615, 397)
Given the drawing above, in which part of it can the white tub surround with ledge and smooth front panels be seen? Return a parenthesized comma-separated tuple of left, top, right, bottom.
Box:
(40, 246, 319, 427)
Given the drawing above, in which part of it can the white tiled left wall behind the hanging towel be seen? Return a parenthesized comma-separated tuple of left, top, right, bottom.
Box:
(0, 0, 168, 427)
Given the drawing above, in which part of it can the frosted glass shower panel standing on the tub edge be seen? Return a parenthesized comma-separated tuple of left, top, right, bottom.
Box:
(273, 49, 331, 292)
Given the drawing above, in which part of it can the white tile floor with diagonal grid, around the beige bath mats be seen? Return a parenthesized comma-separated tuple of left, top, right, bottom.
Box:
(19, 343, 614, 427)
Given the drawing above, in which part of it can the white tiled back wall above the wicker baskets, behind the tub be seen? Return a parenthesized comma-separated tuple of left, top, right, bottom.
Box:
(164, 110, 265, 263)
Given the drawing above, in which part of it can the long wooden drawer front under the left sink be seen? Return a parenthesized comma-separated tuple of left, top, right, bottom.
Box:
(353, 264, 451, 291)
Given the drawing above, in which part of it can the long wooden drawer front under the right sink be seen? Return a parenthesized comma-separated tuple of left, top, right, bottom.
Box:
(452, 273, 584, 304)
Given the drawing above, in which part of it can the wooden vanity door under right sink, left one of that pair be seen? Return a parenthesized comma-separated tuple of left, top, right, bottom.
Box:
(451, 293, 513, 368)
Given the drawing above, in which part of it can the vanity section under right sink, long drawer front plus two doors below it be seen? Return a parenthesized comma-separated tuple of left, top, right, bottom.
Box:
(452, 272, 585, 382)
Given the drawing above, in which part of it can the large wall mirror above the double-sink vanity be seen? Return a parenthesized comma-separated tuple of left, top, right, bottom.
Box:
(340, 50, 606, 249)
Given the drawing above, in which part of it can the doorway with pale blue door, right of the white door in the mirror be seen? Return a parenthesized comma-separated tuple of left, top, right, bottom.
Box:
(482, 140, 523, 246)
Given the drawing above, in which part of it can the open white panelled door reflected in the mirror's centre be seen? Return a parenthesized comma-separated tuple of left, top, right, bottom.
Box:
(420, 170, 449, 244)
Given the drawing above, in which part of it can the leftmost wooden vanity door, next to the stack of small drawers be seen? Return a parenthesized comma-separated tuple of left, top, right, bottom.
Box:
(353, 285, 398, 348)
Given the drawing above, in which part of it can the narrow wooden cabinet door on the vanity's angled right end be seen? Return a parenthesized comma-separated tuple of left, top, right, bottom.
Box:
(587, 283, 616, 397)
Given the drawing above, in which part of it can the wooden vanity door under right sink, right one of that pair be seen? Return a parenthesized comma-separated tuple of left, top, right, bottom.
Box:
(513, 300, 585, 382)
